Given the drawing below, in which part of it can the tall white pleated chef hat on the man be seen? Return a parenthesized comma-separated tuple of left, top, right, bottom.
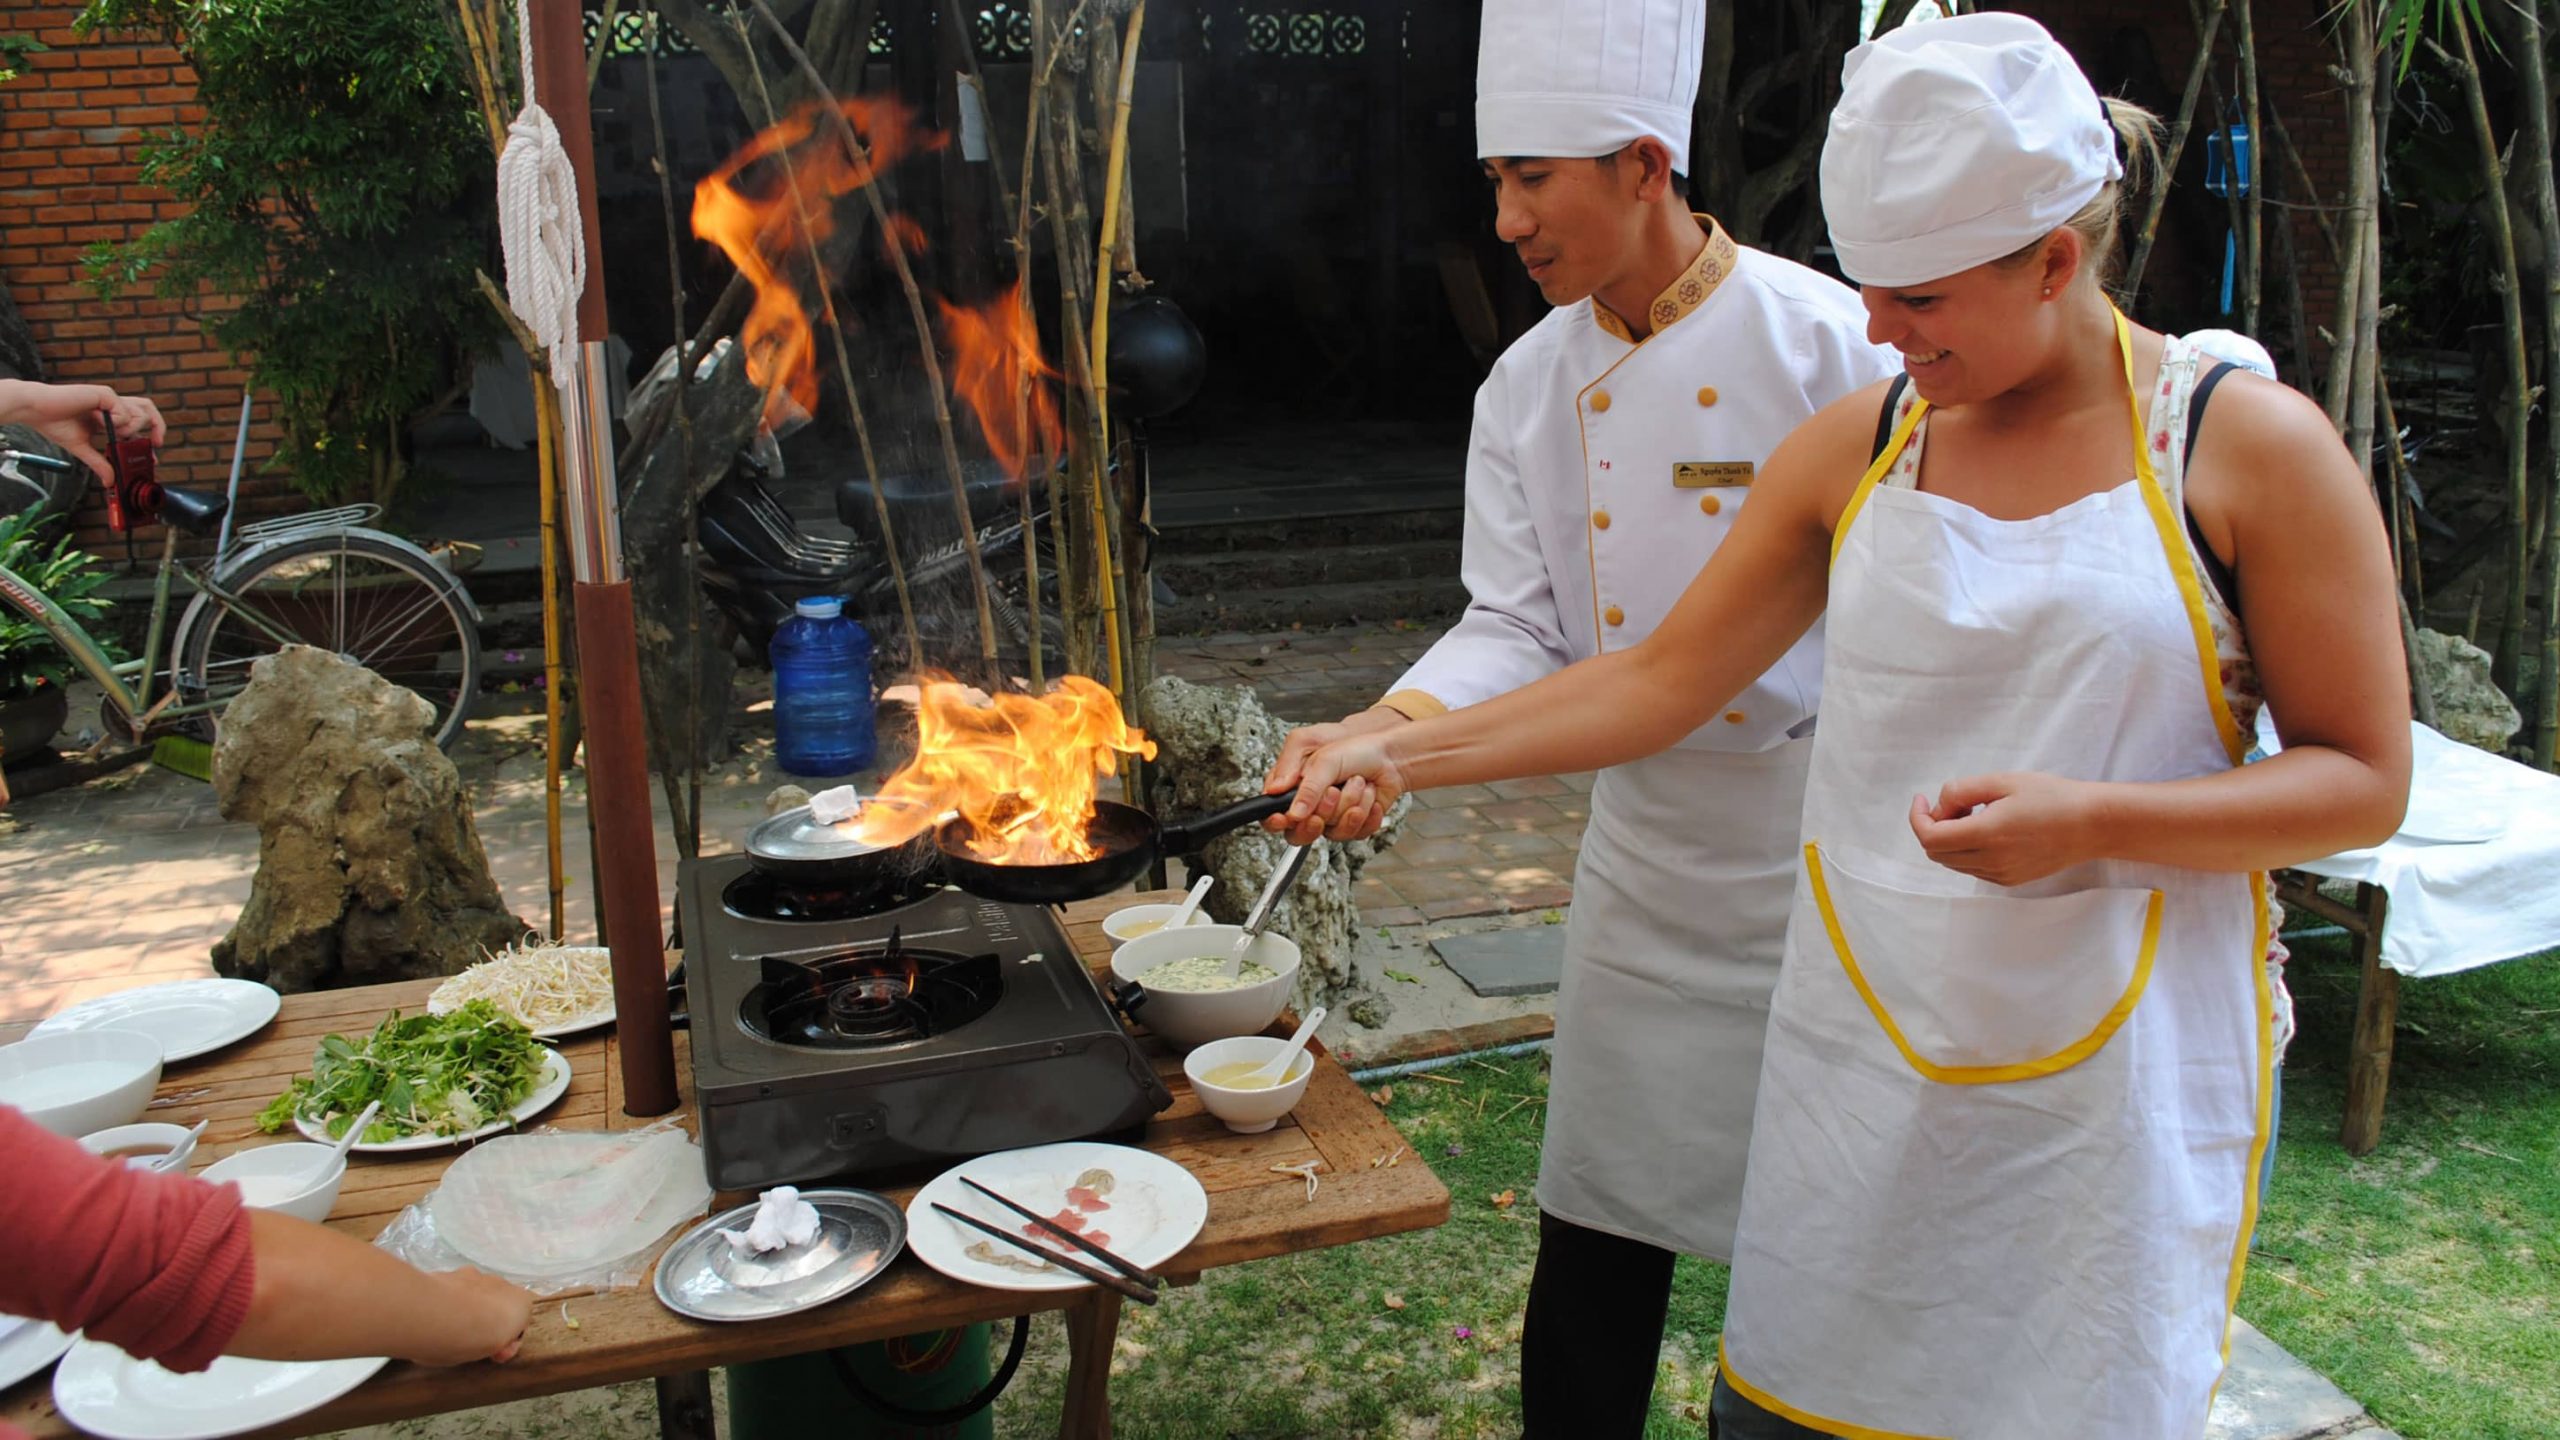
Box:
(1475, 0, 1708, 174)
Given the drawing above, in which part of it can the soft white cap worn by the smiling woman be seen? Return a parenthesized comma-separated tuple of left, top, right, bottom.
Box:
(1823, 13, 2125, 284)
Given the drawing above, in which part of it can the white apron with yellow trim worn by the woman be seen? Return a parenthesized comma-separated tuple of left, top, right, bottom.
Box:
(1723, 320, 2271, 1440)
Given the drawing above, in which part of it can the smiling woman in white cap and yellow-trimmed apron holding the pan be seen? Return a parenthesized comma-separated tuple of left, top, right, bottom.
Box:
(1269, 13, 2409, 1440)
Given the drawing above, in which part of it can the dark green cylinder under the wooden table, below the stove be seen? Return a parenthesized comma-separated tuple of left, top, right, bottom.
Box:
(727, 1325, 996, 1440)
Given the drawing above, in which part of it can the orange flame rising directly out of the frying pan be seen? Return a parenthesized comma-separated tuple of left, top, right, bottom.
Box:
(855, 674, 1155, 866)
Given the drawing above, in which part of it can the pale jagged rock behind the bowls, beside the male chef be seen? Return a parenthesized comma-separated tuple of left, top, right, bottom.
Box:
(1139, 676, 1411, 1010)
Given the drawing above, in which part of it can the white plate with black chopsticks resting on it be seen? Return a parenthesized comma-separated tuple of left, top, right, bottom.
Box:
(906, 1140, 1208, 1291)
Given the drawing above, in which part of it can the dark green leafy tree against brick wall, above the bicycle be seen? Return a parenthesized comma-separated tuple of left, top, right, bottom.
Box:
(79, 0, 497, 502)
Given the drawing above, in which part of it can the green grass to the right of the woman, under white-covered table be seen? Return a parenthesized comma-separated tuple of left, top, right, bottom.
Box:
(2240, 943, 2560, 1440)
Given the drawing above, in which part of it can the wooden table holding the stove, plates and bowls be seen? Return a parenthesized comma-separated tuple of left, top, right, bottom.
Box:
(0, 892, 1449, 1437)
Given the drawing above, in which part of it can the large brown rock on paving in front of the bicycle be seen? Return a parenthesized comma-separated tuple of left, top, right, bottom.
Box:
(212, 646, 527, 992)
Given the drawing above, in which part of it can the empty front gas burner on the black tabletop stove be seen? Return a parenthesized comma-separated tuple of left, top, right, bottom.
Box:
(737, 933, 1004, 1051)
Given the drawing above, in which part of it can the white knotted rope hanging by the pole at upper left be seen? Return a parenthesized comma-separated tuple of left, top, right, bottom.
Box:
(497, 0, 586, 387)
